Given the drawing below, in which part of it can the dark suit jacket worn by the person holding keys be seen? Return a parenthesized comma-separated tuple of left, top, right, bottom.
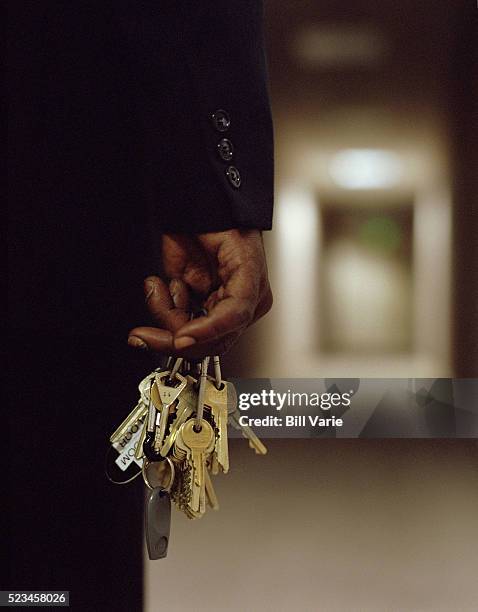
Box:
(8, 0, 273, 334)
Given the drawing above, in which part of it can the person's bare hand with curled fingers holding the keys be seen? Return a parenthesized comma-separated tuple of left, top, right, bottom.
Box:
(128, 230, 272, 359)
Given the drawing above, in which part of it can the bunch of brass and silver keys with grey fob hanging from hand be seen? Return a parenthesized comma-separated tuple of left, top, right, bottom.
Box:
(107, 356, 267, 559)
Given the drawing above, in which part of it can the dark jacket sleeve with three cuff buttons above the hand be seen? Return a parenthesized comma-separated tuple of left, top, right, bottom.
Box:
(115, 0, 273, 233)
